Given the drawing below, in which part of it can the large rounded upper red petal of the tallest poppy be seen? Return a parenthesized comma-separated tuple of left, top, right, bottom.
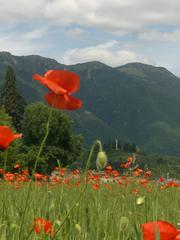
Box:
(44, 70, 80, 94)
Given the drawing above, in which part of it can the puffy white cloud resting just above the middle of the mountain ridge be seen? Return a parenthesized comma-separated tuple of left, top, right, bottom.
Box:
(60, 41, 152, 67)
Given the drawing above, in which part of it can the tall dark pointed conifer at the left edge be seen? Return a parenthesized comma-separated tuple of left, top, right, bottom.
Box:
(1, 66, 27, 131)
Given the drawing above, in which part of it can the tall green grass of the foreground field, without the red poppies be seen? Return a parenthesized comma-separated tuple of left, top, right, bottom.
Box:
(0, 179, 180, 240)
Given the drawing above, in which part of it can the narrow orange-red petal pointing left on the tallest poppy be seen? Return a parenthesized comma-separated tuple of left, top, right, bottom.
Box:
(32, 74, 67, 94)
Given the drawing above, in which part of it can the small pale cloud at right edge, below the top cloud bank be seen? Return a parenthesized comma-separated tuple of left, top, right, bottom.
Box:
(138, 29, 180, 44)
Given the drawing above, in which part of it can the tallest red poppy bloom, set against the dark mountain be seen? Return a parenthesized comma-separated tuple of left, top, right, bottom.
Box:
(32, 70, 82, 110)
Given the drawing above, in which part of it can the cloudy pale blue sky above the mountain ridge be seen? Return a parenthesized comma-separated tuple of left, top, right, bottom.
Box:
(0, 0, 180, 76)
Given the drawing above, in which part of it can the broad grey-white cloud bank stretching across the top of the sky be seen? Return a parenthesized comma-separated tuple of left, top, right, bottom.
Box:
(0, 0, 180, 34)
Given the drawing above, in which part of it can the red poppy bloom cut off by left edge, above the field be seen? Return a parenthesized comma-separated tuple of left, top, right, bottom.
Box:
(0, 126, 22, 150)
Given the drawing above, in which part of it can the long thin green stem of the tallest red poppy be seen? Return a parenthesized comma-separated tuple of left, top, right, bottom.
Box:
(19, 108, 53, 240)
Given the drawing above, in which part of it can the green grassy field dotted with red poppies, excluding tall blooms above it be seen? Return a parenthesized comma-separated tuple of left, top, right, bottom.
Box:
(0, 166, 180, 240)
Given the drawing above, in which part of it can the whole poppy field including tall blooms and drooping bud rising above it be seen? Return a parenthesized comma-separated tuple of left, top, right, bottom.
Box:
(0, 70, 180, 240)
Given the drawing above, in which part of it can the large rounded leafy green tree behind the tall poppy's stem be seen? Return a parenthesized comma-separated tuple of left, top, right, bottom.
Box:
(22, 103, 83, 172)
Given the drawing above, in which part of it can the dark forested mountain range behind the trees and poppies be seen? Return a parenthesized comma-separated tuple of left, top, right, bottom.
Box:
(0, 52, 180, 155)
